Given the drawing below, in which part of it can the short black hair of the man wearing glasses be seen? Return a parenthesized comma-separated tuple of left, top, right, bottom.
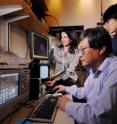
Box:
(80, 27, 112, 56)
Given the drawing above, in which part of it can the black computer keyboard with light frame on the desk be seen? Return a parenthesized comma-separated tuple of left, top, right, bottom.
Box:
(29, 96, 58, 123)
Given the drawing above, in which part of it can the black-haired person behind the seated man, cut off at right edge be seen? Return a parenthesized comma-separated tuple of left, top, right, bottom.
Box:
(103, 4, 117, 56)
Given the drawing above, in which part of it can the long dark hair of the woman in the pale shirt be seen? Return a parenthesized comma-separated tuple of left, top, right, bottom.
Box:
(58, 29, 77, 54)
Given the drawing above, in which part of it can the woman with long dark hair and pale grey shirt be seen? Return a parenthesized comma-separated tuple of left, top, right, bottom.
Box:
(47, 30, 79, 92)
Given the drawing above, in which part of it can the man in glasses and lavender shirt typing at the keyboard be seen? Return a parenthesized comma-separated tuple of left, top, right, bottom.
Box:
(54, 27, 117, 124)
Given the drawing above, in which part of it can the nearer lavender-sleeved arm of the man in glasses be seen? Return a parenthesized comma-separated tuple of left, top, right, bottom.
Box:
(64, 72, 117, 124)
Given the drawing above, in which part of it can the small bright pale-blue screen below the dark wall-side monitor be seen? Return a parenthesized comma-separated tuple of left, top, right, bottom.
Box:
(39, 64, 50, 79)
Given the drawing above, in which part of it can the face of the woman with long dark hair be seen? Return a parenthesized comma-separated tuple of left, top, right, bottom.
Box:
(61, 32, 71, 46)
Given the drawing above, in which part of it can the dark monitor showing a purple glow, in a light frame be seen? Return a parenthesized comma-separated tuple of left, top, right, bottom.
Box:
(31, 32, 49, 59)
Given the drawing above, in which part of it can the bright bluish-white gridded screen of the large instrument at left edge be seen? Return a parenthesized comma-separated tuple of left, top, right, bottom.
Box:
(0, 73, 19, 105)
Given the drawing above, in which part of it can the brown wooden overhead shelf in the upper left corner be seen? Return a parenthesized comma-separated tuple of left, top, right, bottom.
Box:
(0, 0, 48, 35)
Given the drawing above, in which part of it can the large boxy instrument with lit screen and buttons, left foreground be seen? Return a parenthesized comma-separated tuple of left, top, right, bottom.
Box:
(0, 68, 30, 124)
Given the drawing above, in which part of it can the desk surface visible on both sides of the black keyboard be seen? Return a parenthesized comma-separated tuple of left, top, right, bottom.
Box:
(2, 100, 74, 124)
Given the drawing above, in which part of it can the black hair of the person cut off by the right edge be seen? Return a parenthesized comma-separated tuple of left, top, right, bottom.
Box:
(103, 4, 117, 23)
